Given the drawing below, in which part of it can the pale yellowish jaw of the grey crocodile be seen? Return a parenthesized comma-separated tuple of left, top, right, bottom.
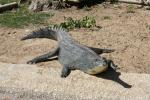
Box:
(86, 65, 108, 75)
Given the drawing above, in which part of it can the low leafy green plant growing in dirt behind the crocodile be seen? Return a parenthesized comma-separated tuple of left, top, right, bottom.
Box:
(50, 16, 96, 30)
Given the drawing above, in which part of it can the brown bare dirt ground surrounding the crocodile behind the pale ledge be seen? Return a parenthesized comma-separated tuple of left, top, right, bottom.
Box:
(0, 4, 150, 73)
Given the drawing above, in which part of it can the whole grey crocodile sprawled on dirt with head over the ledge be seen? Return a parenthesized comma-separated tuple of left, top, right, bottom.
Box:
(21, 27, 116, 78)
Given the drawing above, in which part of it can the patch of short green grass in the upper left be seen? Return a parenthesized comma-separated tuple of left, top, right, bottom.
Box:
(0, 5, 54, 28)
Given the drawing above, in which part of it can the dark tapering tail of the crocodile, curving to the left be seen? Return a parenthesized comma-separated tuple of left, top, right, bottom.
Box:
(21, 27, 57, 40)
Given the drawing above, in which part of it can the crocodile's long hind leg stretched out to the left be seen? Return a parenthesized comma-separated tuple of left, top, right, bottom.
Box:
(27, 48, 59, 64)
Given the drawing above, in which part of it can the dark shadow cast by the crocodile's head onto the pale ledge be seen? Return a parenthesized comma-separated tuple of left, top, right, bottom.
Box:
(95, 67, 132, 88)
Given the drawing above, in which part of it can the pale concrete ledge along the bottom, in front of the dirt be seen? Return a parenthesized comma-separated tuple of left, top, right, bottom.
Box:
(0, 63, 150, 100)
